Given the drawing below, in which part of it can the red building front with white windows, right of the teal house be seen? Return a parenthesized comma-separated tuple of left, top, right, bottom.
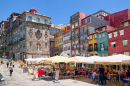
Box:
(108, 20, 130, 55)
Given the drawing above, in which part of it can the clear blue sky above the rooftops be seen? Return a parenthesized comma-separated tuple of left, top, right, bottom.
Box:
(0, 0, 130, 25)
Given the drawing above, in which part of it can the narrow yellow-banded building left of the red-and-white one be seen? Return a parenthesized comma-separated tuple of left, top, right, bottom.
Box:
(54, 31, 63, 55)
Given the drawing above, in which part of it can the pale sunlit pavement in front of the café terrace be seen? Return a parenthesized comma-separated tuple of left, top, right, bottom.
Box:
(0, 60, 96, 86)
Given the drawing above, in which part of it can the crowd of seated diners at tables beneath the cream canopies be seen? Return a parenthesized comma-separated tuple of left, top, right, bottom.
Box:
(33, 65, 130, 85)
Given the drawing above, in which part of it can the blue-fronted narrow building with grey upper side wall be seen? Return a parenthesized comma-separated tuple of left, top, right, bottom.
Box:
(79, 15, 109, 57)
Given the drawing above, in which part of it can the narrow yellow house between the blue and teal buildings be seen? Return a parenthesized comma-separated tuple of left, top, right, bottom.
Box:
(88, 33, 98, 56)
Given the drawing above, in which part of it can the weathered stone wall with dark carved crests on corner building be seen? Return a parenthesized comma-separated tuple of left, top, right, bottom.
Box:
(26, 22, 50, 58)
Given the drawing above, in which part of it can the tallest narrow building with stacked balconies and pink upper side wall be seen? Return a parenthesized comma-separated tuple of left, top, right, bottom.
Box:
(70, 12, 88, 56)
